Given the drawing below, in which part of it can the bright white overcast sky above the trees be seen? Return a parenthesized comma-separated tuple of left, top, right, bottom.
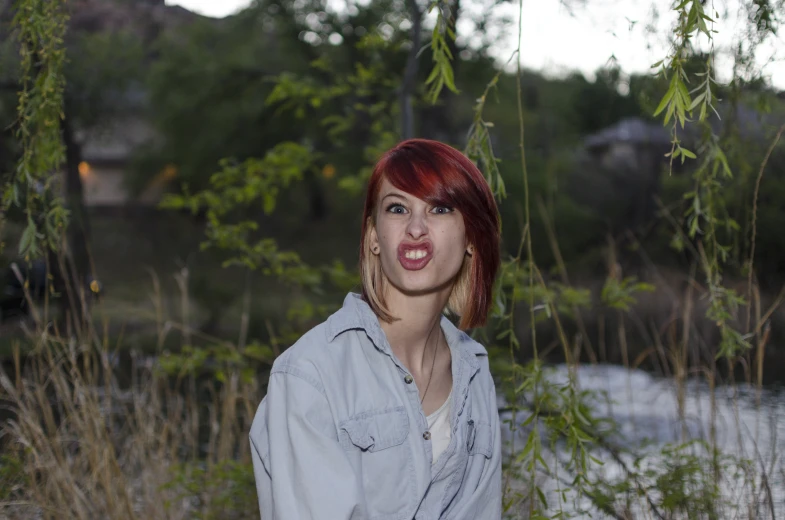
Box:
(167, 0, 785, 90)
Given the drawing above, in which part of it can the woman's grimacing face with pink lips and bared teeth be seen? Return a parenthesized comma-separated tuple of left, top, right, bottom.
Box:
(369, 179, 469, 295)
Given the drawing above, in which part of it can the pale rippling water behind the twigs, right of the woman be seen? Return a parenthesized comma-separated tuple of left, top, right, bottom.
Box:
(499, 365, 785, 518)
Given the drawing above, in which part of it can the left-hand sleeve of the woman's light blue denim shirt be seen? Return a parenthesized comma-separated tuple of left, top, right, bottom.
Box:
(250, 365, 367, 520)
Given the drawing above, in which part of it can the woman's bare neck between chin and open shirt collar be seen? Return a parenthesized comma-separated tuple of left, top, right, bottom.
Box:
(380, 284, 451, 374)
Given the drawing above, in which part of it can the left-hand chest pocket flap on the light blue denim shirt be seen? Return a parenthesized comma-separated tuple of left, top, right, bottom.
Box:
(340, 406, 409, 452)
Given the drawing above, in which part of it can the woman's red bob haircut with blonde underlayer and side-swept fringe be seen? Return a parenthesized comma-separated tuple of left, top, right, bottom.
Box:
(360, 139, 500, 330)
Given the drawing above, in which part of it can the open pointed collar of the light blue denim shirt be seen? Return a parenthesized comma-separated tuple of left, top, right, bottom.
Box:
(327, 293, 488, 369)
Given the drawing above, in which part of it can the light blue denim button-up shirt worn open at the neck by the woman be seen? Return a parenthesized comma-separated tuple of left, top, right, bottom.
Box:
(250, 293, 502, 520)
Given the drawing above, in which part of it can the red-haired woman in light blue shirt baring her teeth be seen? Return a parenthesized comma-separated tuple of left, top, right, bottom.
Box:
(250, 139, 501, 520)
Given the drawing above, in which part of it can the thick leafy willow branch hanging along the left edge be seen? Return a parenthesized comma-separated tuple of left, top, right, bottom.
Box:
(3, 0, 68, 258)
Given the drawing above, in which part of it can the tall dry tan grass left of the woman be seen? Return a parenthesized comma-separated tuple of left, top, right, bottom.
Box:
(0, 268, 262, 519)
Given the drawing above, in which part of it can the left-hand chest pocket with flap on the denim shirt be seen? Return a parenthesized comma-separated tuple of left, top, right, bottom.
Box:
(339, 406, 417, 520)
